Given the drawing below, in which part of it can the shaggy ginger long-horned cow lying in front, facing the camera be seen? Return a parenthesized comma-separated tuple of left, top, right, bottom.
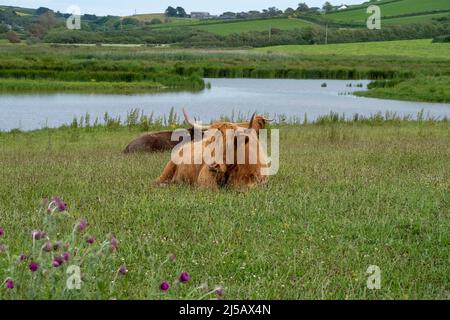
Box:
(155, 112, 267, 191)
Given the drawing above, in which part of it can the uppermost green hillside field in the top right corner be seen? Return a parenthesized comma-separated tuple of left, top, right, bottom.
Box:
(325, 0, 450, 23)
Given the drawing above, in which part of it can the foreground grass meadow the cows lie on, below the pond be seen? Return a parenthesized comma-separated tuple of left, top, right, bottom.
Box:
(0, 122, 450, 299)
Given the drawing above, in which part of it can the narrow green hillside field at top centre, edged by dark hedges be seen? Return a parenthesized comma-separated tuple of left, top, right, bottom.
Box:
(196, 19, 311, 35)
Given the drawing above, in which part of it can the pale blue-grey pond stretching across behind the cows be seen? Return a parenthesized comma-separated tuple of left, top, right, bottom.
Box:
(0, 79, 450, 131)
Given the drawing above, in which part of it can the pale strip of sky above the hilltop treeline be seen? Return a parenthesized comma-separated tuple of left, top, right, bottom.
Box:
(0, 0, 364, 16)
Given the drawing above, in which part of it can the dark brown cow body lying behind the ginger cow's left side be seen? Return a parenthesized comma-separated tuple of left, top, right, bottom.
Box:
(123, 128, 194, 154)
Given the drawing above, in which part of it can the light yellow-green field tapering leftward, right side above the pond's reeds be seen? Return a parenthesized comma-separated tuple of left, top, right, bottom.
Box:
(255, 40, 450, 60)
